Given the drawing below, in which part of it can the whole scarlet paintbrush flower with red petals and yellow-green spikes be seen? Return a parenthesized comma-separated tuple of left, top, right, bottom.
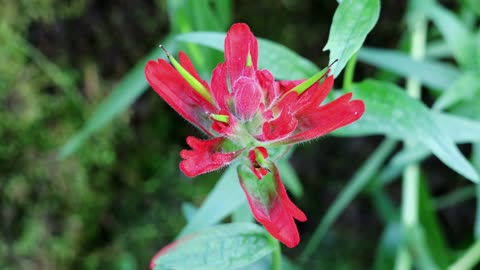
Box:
(145, 23, 364, 247)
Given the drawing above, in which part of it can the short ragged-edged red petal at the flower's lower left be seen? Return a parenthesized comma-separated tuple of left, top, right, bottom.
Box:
(180, 136, 239, 177)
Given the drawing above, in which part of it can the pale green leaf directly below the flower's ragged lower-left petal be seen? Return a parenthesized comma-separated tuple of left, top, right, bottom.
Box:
(179, 164, 247, 237)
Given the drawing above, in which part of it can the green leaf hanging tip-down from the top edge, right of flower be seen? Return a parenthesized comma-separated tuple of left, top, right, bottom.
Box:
(323, 0, 380, 77)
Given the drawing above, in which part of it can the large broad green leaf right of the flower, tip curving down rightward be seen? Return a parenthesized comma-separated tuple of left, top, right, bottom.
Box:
(337, 80, 479, 182)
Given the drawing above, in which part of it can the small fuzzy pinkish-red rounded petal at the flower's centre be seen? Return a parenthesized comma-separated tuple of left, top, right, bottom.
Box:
(232, 77, 262, 121)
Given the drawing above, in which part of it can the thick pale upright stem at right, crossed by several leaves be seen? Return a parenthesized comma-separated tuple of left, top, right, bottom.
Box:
(395, 4, 427, 270)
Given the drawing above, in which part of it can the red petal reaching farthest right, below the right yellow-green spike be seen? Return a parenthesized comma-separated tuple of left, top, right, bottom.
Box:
(283, 93, 365, 143)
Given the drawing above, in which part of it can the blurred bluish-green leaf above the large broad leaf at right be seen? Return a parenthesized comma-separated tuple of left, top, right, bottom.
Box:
(358, 48, 460, 90)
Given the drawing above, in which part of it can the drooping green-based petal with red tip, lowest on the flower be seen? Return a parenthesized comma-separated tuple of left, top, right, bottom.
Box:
(239, 163, 307, 248)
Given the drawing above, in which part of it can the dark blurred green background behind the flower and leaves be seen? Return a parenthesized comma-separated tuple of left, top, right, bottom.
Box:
(0, 0, 474, 270)
